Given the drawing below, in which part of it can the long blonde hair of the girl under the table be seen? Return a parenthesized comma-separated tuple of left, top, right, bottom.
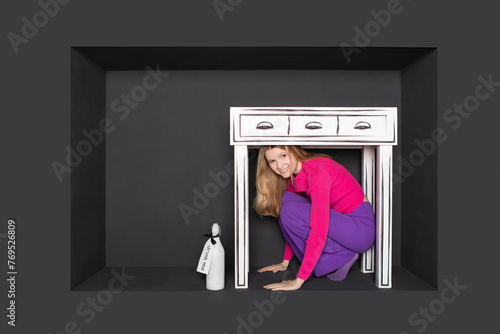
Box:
(253, 145, 332, 218)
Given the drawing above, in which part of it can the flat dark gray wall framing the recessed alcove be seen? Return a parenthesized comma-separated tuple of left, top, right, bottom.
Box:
(0, 0, 500, 334)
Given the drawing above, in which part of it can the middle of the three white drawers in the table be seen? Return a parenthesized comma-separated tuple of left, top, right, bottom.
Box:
(290, 116, 338, 137)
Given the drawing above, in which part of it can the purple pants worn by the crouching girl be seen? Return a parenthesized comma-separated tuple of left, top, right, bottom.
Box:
(278, 191, 375, 276)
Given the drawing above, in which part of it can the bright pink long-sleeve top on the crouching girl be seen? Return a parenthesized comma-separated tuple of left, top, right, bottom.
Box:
(283, 158, 364, 280)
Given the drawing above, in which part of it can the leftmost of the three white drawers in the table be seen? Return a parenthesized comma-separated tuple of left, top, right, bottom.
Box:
(240, 115, 288, 137)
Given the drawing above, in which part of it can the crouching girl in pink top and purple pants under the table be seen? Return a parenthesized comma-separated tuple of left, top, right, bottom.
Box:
(254, 146, 375, 290)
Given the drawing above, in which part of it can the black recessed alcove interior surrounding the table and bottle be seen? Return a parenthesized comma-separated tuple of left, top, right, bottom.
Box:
(71, 47, 437, 291)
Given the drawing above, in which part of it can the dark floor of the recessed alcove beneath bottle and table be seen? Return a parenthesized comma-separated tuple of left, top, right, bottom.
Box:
(72, 263, 436, 292)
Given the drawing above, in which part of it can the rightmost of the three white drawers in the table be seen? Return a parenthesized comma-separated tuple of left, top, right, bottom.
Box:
(338, 115, 387, 137)
